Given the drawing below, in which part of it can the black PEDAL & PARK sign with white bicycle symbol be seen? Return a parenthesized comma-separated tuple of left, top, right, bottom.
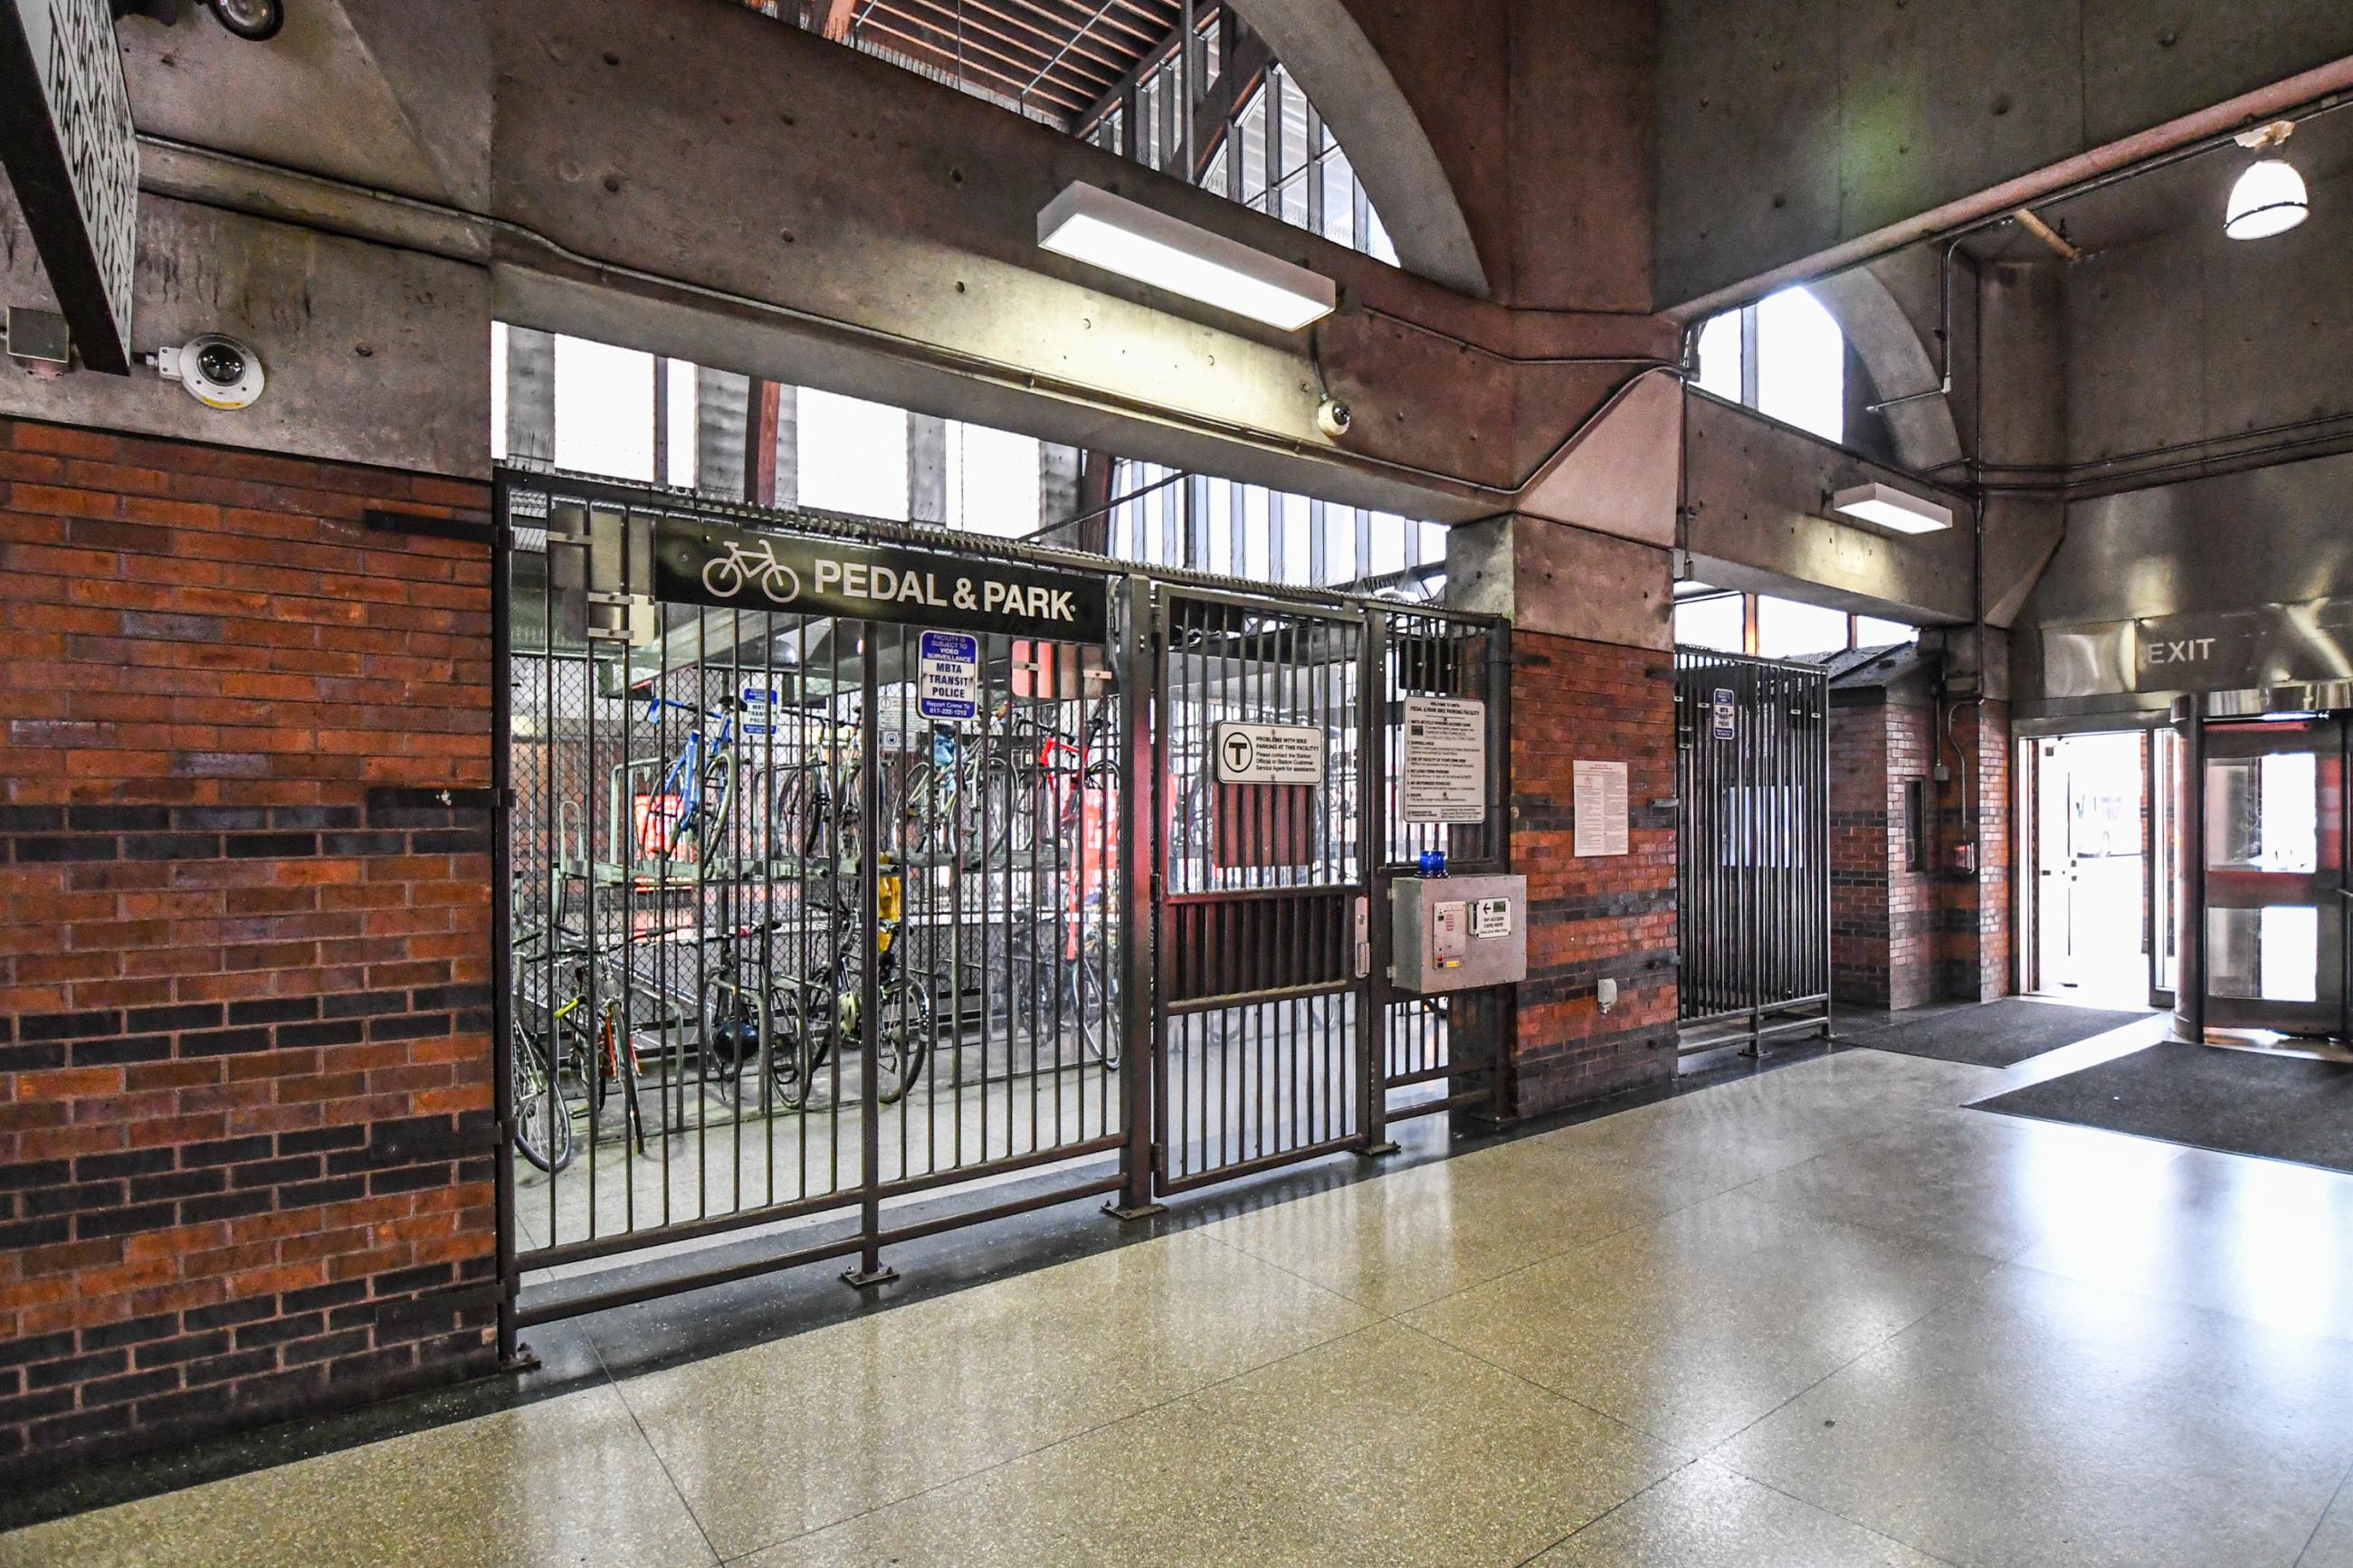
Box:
(653, 517, 1110, 641)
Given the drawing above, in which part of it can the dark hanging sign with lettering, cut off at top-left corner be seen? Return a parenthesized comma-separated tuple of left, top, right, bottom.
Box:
(0, 0, 138, 376)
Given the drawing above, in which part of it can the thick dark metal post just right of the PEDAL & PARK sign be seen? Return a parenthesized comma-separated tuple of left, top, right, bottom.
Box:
(1103, 571, 1165, 1220)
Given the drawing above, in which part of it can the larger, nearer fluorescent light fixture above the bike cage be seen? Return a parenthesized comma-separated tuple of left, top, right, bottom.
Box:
(1038, 181, 1338, 331)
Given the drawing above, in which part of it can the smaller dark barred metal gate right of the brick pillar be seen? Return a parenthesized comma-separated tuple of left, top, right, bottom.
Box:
(1675, 649, 1831, 1053)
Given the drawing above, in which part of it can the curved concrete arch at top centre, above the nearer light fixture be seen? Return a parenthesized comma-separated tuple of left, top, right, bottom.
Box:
(1235, 0, 1490, 299)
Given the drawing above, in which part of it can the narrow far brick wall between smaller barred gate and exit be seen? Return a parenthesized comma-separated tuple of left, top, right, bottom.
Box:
(1831, 691, 1939, 1011)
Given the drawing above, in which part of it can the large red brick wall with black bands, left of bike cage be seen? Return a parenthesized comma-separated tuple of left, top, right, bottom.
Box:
(0, 421, 494, 1477)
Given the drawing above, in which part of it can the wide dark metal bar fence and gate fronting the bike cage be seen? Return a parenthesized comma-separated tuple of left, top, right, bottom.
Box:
(494, 472, 1509, 1354)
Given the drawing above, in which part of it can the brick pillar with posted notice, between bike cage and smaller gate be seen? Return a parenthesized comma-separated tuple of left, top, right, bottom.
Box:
(1510, 632, 1675, 1115)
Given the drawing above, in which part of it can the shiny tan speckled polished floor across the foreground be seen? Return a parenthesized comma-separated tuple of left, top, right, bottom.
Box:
(0, 1041, 2353, 1568)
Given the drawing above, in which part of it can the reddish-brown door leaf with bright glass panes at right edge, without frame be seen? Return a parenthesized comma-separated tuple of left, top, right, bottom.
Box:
(2203, 717, 2346, 1037)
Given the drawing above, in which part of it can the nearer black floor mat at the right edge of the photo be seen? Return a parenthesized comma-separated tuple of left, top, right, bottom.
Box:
(1977, 1041, 2353, 1171)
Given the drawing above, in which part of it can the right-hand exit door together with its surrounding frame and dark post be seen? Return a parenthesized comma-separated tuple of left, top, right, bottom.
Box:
(2174, 687, 2353, 1049)
